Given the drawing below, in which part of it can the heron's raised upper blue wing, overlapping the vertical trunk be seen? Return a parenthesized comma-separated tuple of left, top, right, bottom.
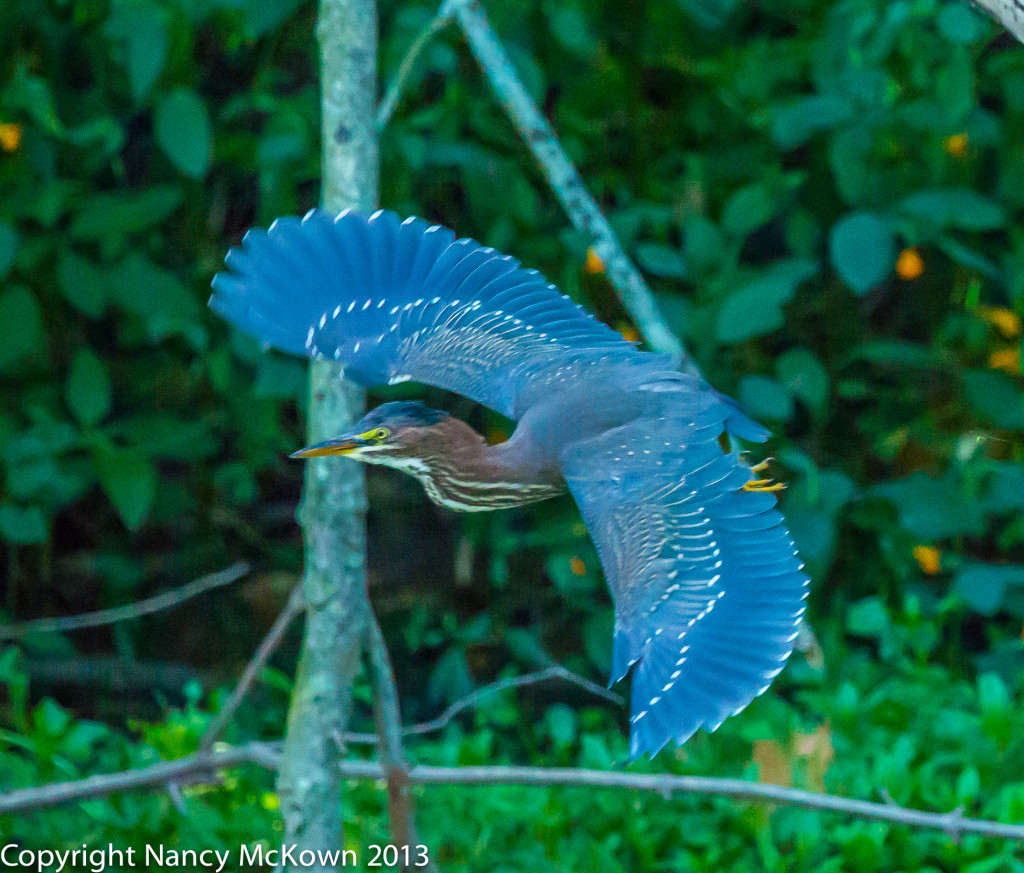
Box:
(210, 210, 635, 418)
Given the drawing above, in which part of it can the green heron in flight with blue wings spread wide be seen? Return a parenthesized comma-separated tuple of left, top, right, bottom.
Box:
(210, 210, 809, 756)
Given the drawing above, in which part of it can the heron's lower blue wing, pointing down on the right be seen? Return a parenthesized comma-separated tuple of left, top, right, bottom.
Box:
(562, 393, 809, 755)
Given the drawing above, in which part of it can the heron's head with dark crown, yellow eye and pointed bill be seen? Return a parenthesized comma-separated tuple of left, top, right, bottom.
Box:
(292, 401, 449, 466)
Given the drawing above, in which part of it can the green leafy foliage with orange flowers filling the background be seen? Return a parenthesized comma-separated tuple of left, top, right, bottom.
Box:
(0, 0, 1024, 873)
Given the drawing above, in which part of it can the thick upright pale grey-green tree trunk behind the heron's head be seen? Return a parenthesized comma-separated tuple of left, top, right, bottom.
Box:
(278, 0, 378, 869)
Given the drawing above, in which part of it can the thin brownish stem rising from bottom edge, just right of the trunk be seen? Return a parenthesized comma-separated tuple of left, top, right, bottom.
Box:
(367, 610, 434, 858)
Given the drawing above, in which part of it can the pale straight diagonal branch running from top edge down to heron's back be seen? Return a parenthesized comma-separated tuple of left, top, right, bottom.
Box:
(444, 0, 696, 373)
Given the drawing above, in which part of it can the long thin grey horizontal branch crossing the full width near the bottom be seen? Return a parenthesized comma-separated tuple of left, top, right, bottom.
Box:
(0, 743, 1024, 841)
